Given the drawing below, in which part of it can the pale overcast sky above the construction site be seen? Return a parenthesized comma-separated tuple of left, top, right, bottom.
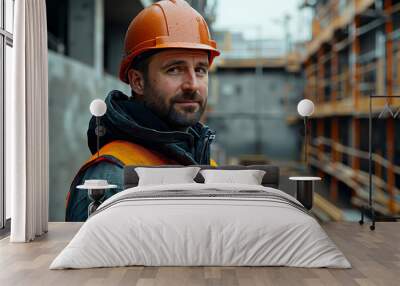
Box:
(214, 0, 311, 40)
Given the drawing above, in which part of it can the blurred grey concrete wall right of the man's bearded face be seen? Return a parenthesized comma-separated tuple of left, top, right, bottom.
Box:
(207, 70, 302, 160)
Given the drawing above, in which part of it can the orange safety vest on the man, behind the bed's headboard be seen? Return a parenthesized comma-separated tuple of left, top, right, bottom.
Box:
(66, 140, 217, 213)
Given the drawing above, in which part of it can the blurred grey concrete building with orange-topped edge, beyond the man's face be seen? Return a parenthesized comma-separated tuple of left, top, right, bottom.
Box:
(207, 31, 303, 163)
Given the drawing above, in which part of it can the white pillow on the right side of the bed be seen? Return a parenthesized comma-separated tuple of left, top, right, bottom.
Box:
(200, 170, 266, 185)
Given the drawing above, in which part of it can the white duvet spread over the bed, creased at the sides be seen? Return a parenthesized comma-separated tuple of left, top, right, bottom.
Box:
(50, 183, 351, 269)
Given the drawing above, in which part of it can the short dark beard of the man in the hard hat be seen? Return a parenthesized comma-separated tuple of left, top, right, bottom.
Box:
(143, 86, 207, 129)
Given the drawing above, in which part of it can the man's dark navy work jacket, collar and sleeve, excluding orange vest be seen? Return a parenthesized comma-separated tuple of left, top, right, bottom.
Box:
(66, 90, 215, 221)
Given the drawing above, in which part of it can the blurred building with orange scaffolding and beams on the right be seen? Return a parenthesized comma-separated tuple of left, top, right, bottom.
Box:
(303, 0, 400, 214)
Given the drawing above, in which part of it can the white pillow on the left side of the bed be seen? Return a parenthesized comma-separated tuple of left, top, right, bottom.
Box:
(135, 167, 200, 186)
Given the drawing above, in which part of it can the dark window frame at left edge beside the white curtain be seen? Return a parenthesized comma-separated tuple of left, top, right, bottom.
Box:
(0, 0, 15, 232)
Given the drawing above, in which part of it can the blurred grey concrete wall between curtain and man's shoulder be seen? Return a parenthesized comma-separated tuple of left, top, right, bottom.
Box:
(49, 51, 130, 221)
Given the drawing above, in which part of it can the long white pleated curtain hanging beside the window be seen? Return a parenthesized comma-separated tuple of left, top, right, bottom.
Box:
(6, 0, 49, 242)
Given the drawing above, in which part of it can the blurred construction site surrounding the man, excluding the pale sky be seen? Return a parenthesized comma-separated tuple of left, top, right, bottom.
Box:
(46, 0, 400, 221)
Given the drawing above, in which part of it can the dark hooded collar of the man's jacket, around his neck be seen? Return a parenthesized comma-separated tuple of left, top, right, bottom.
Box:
(87, 90, 215, 165)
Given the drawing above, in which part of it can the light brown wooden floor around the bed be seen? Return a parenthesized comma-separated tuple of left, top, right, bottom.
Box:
(0, 222, 400, 286)
